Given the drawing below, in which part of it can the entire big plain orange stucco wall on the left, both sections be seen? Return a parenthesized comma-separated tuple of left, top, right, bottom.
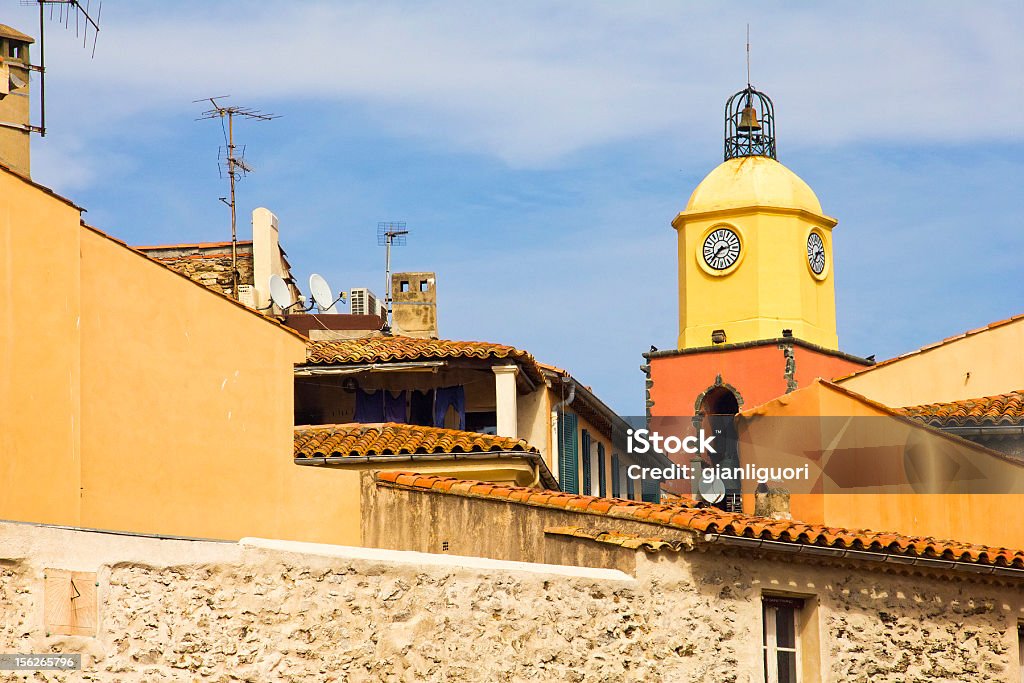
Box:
(0, 169, 387, 545)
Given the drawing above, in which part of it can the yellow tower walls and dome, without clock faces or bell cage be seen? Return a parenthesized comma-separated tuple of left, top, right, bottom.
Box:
(672, 158, 838, 348)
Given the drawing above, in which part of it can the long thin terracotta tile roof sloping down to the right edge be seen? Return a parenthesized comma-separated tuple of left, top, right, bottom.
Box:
(377, 472, 1024, 568)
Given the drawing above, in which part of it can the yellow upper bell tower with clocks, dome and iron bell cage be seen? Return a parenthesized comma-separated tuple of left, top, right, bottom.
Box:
(672, 85, 839, 349)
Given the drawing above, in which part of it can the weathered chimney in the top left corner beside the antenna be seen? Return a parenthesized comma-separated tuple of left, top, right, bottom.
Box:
(0, 24, 35, 177)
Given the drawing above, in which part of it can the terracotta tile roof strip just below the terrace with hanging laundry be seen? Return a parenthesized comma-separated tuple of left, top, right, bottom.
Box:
(295, 422, 539, 458)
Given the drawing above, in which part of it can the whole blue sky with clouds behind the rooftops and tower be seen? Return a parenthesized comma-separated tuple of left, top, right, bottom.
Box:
(9, 0, 1024, 414)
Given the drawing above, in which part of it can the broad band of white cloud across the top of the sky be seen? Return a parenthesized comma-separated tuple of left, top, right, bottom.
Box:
(9, 2, 1024, 166)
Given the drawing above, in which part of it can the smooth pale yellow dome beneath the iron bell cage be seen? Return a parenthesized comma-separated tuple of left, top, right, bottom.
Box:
(686, 157, 821, 215)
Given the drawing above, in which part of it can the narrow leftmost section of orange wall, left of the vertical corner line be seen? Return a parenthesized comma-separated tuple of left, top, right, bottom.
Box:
(0, 169, 82, 523)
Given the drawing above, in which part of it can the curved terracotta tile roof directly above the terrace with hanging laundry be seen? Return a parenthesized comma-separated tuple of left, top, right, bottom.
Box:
(306, 336, 543, 383)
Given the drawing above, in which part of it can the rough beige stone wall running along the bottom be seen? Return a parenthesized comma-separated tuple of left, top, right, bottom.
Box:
(0, 523, 1024, 683)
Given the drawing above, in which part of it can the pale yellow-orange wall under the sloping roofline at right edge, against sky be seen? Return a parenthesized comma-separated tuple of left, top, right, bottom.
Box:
(837, 316, 1024, 407)
